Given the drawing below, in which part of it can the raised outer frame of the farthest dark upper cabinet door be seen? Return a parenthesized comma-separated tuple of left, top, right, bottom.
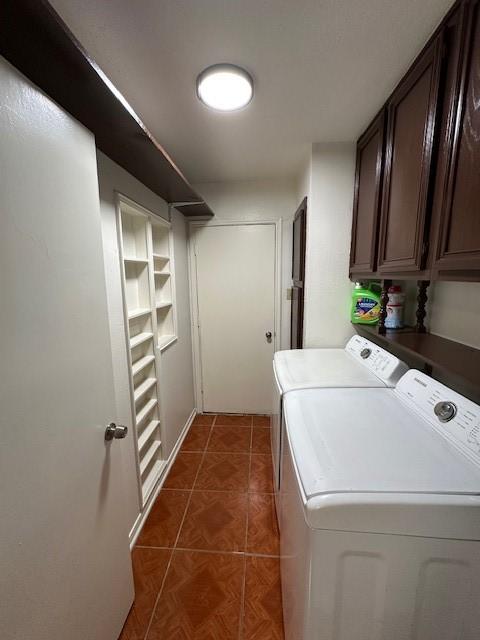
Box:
(350, 107, 386, 277)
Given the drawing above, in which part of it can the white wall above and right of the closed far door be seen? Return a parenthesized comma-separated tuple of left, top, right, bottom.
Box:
(195, 180, 301, 349)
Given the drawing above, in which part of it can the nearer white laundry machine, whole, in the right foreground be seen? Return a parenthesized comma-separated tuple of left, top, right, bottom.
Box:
(280, 369, 480, 640)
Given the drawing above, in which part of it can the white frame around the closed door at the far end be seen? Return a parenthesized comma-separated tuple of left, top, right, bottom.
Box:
(188, 218, 282, 413)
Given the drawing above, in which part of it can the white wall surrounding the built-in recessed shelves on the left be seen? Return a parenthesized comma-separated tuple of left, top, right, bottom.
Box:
(97, 151, 194, 526)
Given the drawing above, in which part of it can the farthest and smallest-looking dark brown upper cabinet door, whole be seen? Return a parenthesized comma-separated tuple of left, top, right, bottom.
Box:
(350, 109, 385, 277)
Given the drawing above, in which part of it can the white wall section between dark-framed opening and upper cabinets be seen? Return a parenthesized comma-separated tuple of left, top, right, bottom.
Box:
(299, 143, 355, 348)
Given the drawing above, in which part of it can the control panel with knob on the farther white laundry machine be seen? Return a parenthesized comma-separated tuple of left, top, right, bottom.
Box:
(345, 335, 408, 387)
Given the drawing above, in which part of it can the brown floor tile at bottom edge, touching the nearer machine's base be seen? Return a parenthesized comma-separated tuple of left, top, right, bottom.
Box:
(243, 557, 284, 640)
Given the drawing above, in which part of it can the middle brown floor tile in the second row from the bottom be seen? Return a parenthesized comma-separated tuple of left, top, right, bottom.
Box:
(177, 491, 248, 551)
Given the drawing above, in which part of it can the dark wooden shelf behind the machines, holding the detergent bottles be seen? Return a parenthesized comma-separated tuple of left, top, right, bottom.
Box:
(354, 324, 480, 403)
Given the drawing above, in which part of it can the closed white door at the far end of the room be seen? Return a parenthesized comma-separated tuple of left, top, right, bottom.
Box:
(193, 224, 275, 413)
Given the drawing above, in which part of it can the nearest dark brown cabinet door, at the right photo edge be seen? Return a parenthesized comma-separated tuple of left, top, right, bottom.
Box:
(433, 0, 480, 280)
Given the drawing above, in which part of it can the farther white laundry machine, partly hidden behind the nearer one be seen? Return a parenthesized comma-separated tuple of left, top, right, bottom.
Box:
(271, 335, 408, 504)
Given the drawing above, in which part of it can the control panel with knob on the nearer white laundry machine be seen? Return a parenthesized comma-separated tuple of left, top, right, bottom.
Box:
(395, 369, 480, 465)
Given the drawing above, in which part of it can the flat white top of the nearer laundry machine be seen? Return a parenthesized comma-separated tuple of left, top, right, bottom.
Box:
(284, 389, 480, 501)
